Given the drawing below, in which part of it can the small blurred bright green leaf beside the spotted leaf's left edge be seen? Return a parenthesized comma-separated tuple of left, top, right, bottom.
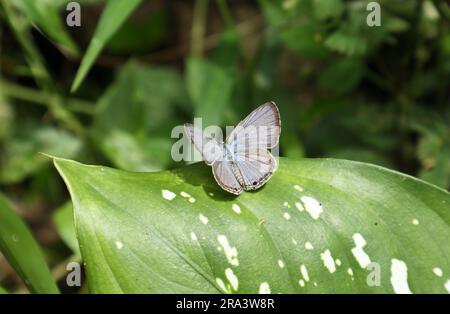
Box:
(52, 202, 80, 255)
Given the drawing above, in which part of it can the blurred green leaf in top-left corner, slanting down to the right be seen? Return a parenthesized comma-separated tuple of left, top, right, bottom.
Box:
(14, 0, 79, 55)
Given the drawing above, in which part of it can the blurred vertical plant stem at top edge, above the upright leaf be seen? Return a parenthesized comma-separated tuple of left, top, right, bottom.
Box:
(191, 0, 208, 57)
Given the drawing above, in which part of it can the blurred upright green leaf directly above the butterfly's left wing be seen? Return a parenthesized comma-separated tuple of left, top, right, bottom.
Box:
(186, 58, 234, 127)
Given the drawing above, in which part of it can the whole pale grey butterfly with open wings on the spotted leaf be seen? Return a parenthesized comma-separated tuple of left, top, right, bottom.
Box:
(184, 102, 281, 195)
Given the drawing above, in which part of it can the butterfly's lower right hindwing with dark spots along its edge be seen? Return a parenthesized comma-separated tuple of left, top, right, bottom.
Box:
(234, 149, 277, 191)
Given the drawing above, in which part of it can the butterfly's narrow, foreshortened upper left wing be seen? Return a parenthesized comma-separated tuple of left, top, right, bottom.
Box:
(184, 123, 223, 165)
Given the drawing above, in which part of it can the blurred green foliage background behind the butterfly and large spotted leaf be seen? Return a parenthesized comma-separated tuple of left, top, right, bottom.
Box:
(0, 0, 450, 290)
